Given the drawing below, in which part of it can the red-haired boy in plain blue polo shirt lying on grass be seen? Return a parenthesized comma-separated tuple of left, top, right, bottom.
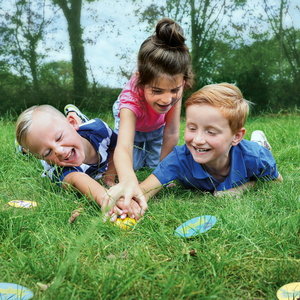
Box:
(105, 83, 282, 216)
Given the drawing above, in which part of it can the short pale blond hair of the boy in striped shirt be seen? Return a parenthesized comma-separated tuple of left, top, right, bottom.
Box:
(16, 104, 65, 147)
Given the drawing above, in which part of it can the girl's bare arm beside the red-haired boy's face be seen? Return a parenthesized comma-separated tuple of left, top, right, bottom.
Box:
(160, 99, 182, 160)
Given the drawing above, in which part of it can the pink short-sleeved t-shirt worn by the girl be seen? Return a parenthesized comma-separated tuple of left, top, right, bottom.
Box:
(119, 75, 166, 132)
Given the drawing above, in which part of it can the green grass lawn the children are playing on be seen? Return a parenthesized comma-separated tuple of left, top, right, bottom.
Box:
(0, 114, 300, 300)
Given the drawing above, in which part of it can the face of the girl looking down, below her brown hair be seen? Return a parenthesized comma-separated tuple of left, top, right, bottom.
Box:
(145, 74, 184, 114)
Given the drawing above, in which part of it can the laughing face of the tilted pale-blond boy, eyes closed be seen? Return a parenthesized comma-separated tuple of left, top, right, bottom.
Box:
(25, 111, 85, 166)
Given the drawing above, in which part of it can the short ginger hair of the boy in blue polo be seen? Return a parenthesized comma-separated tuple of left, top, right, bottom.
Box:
(185, 82, 251, 132)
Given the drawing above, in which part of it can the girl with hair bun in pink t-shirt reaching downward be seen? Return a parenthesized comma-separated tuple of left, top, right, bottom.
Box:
(106, 18, 193, 218)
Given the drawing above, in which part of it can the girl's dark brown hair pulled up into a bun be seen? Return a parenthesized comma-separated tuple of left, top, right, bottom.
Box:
(137, 18, 193, 88)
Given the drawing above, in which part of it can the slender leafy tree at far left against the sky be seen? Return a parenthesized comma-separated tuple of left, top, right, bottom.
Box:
(0, 0, 52, 92)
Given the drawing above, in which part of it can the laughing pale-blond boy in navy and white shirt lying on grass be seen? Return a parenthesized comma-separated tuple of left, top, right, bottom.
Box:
(16, 105, 129, 210)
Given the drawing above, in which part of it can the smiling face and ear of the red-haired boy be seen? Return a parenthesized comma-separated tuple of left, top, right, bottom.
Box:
(184, 104, 245, 171)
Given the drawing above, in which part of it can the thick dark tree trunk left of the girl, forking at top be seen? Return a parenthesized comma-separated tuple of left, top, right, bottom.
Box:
(52, 0, 88, 100)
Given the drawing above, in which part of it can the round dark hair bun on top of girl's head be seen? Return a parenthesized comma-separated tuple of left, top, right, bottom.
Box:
(154, 18, 185, 47)
